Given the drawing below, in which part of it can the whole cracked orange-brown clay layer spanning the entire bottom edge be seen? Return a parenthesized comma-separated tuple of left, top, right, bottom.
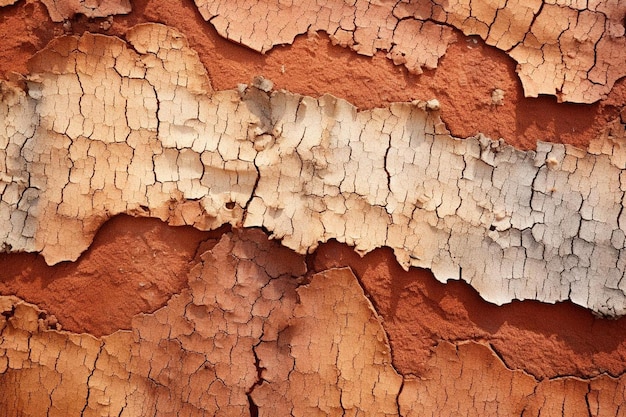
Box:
(0, 229, 626, 417)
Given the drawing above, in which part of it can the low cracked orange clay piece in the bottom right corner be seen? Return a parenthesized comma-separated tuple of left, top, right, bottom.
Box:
(398, 342, 626, 417)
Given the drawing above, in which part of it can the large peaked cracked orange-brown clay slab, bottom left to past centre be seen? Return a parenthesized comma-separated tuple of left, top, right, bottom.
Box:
(0, 231, 402, 416)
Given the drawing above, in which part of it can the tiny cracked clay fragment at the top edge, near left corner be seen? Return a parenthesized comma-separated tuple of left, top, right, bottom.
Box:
(41, 0, 132, 22)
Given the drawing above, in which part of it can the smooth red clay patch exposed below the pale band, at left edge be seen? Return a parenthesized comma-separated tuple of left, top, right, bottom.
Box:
(0, 216, 223, 336)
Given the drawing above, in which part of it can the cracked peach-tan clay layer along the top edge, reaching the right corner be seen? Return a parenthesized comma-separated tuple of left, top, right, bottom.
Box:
(195, 0, 626, 103)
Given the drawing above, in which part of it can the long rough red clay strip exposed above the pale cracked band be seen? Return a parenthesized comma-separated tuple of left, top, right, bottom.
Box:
(0, 0, 626, 149)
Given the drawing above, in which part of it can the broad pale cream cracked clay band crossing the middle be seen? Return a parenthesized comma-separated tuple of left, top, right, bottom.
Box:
(0, 24, 626, 315)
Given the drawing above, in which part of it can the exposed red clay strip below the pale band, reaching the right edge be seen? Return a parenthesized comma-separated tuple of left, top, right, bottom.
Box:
(309, 242, 626, 378)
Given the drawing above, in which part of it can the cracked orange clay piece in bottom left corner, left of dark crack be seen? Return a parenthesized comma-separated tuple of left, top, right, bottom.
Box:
(0, 297, 102, 416)
